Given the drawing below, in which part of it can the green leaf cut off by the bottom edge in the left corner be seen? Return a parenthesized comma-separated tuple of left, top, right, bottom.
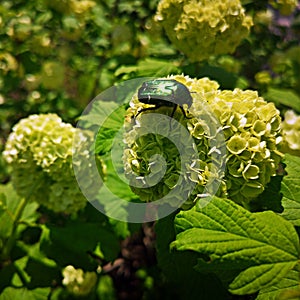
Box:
(0, 287, 51, 300)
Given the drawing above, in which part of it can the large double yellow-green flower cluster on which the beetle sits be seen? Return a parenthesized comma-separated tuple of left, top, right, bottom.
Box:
(124, 75, 282, 209)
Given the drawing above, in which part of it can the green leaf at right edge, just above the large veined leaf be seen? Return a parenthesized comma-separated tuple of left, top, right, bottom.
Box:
(281, 154, 300, 226)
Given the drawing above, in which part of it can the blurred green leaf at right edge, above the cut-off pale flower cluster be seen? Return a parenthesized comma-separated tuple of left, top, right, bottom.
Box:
(264, 88, 300, 112)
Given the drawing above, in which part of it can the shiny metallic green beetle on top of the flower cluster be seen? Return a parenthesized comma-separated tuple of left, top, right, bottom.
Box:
(136, 79, 193, 117)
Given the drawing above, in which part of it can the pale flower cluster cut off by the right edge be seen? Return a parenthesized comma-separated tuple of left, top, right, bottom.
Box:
(281, 110, 300, 156)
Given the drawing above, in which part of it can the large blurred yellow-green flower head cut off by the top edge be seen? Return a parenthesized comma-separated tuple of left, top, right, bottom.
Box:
(156, 0, 252, 61)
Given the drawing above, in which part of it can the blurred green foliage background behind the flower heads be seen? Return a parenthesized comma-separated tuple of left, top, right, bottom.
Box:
(0, 0, 300, 182)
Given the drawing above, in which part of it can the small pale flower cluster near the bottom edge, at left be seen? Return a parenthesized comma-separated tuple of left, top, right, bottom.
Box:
(62, 265, 97, 296)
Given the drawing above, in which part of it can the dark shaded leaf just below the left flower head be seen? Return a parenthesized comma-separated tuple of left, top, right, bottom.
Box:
(41, 220, 120, 268)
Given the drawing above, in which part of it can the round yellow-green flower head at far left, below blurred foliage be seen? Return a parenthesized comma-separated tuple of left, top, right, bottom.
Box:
(3, 114, 101, 213)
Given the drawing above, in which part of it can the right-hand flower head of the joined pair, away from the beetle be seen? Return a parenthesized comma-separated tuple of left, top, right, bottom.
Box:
(205, 89, 282, 203)
